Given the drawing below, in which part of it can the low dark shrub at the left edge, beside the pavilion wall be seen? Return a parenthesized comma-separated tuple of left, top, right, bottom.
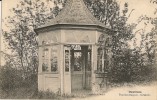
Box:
(0, 65, 37, 92)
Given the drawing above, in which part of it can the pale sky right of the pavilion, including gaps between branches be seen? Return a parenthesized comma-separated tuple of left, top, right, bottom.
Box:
(118, 0, 157, 48)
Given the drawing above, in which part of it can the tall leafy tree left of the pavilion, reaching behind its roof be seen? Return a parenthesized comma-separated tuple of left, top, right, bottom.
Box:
(3, 0, 60, 77)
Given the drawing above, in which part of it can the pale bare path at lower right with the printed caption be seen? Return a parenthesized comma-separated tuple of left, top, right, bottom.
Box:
(72, 84, 157, 100)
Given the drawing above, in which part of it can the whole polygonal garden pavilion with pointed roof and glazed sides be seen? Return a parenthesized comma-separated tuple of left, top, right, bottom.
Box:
(35, 0, 112, 95)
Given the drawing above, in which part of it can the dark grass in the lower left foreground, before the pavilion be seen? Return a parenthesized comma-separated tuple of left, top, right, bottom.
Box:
(0, 87, 85, 100)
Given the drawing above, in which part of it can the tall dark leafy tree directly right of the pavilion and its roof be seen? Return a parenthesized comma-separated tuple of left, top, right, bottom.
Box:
(86, 0, 134, 82)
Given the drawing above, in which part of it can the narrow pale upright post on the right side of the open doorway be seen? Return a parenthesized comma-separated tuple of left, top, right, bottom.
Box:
(91, 45, 97, 94)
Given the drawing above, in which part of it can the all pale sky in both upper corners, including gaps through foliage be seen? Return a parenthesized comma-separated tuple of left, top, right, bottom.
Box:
(0, 0, 157, 65)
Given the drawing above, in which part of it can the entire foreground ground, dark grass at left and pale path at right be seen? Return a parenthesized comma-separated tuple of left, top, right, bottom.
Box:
(0, 82, 157, 100)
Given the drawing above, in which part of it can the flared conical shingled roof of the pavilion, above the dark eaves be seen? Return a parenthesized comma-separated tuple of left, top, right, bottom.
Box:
(40, 0, 105, 28)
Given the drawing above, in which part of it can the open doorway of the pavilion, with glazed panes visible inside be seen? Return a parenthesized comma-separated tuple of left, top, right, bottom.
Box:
(71, 45, 91, 91)
